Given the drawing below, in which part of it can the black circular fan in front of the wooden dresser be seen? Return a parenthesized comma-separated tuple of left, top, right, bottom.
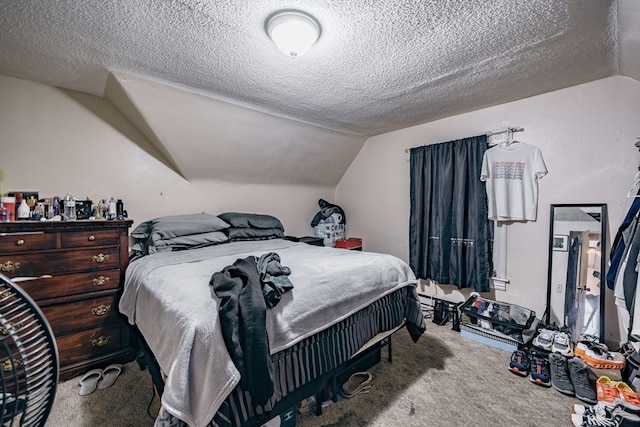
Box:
(0, 273, 59, 427)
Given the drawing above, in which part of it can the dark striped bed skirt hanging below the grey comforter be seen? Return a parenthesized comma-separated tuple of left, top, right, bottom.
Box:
(149, 286, 424, 427)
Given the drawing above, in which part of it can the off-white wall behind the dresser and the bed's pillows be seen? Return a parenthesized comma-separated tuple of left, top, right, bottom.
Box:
(0, 75, 334, 236)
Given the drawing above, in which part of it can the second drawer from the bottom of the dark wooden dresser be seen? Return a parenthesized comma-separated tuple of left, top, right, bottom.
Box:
(41, 295, 120, 336)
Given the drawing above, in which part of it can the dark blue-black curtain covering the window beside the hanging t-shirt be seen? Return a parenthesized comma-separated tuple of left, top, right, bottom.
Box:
(409, 135, 493, 292)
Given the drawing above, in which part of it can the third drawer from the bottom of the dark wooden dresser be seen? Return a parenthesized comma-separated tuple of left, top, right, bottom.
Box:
(18, 269, 120, 300)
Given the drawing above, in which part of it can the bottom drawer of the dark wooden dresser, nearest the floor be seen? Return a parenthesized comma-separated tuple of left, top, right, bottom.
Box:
(56, 323, 123, 366)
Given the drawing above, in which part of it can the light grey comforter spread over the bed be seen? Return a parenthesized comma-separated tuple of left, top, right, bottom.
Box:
(119, 240, 416, 426)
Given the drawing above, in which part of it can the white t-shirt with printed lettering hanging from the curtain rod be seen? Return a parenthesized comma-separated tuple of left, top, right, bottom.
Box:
(480, 142, 547, 221)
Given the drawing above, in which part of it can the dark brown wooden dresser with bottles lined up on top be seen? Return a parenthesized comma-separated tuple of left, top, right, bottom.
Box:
(0, 220, 134, 380)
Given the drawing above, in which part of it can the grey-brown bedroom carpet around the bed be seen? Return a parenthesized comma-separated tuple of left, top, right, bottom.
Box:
(47, 321, 581, 427)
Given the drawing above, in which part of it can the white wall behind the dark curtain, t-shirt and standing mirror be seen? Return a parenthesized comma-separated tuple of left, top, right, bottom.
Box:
(336, 76, 640, 346)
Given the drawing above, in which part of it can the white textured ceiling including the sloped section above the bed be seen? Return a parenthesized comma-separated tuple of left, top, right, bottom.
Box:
(0, 0, 640, 185)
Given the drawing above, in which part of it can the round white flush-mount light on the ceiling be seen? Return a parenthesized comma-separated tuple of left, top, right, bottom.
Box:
(266, 10, 320, 58)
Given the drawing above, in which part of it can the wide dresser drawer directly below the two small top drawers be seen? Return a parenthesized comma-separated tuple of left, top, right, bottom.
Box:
(0, 247, 120, 278)
